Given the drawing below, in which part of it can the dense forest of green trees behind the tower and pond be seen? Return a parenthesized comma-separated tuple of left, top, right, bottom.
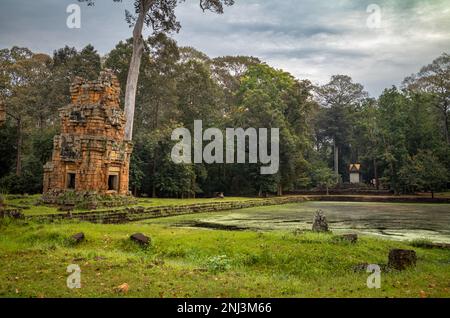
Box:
(0, 34, 450, 197)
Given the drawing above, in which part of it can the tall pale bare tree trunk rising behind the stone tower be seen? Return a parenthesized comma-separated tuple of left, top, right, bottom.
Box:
(125, 0, 149, 141)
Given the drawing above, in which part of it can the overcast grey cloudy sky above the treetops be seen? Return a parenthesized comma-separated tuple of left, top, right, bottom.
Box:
(0, 0, 450, 96)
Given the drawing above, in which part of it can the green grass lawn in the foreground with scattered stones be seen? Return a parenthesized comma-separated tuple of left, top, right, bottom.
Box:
(0, 218, 450, 297)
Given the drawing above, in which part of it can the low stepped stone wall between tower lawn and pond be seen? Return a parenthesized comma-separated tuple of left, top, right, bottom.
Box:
(26, 196, 307, 224)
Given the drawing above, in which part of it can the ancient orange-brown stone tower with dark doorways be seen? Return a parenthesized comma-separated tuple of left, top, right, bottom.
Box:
(44, 71, 132, 195)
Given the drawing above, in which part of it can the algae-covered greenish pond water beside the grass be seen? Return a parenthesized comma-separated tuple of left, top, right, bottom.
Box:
(154, 202, 450, 243)
